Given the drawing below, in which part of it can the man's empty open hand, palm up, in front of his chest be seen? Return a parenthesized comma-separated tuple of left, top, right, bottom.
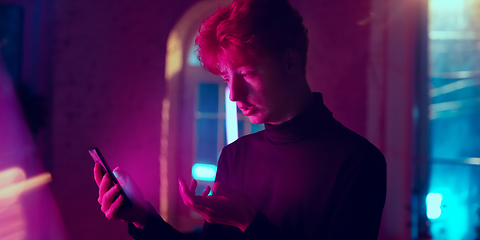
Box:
(179, 179, 257, 231)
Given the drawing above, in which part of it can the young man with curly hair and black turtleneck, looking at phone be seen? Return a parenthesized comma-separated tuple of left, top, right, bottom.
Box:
(94, 0, 386, 239)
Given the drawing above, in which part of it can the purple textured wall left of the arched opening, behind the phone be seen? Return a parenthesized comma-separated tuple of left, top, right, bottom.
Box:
(52, 0, 192, 239)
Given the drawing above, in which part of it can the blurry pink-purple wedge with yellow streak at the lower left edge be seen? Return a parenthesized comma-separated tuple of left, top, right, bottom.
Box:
(0, 55, 67, 240)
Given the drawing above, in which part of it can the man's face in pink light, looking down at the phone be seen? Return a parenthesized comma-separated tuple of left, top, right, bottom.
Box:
(219, 53, 288, 124)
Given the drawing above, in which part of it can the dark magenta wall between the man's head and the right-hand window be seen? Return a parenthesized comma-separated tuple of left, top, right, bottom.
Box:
(291, 0, 370, 135)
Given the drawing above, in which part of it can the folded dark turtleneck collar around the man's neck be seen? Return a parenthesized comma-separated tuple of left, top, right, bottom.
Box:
(265, 93, 334, 142)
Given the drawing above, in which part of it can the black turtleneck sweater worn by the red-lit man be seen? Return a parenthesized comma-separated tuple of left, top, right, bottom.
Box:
(131, 93, 386, 240)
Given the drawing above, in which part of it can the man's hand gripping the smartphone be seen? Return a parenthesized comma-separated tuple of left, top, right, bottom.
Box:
(93, 163, 148, 229)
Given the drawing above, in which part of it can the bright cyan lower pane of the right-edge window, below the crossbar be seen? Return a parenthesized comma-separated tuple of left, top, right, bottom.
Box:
(427, 163, 480, 240)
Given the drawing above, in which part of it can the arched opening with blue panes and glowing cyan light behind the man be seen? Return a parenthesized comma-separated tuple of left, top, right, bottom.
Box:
(159, 0, 263, 232)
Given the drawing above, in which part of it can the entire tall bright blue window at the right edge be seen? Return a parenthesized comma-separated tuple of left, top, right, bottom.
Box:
(426, 0, 480, 240)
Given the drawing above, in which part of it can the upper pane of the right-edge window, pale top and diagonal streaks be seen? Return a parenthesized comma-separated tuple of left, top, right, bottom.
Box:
(429, 0, 480, 161)
